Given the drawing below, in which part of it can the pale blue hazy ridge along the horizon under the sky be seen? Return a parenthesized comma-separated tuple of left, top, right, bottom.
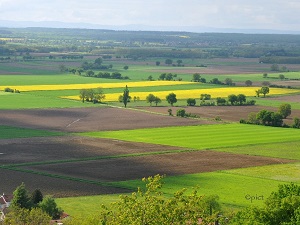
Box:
(0, 20, 300, 34)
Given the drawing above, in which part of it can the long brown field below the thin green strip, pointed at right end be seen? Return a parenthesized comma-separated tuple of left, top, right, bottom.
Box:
(28, 150, 291, 181)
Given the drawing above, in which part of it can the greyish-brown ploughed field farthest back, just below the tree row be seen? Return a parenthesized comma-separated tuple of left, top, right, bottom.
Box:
(0, 107, 212, 132)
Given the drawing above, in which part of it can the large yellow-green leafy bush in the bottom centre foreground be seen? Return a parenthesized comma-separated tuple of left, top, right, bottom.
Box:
(65, 175, 226, 225)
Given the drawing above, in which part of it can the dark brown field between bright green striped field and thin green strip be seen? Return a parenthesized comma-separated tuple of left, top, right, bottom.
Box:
(0, 136, 185, 165)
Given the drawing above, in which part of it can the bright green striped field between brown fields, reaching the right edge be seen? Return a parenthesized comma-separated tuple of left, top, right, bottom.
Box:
(80, 124, 300, 149)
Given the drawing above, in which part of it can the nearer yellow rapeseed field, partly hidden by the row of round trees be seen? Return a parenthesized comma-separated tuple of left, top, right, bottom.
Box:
(63, 87, 299, 101)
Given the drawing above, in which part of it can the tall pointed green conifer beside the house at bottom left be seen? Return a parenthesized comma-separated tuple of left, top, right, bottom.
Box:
(11, 183, 32, 209)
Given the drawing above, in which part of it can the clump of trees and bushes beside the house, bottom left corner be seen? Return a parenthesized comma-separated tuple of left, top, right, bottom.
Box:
(4, 183, 63, 224)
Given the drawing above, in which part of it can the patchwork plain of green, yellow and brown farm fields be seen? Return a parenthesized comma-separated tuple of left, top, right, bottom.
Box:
(0, 29, 300, 222)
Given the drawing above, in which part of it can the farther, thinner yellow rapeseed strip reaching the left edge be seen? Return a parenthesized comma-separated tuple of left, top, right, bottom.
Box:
(0, 81, 192, 92)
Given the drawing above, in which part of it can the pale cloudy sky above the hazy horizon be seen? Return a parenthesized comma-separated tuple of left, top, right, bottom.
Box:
(0, 0, 300, 31)
